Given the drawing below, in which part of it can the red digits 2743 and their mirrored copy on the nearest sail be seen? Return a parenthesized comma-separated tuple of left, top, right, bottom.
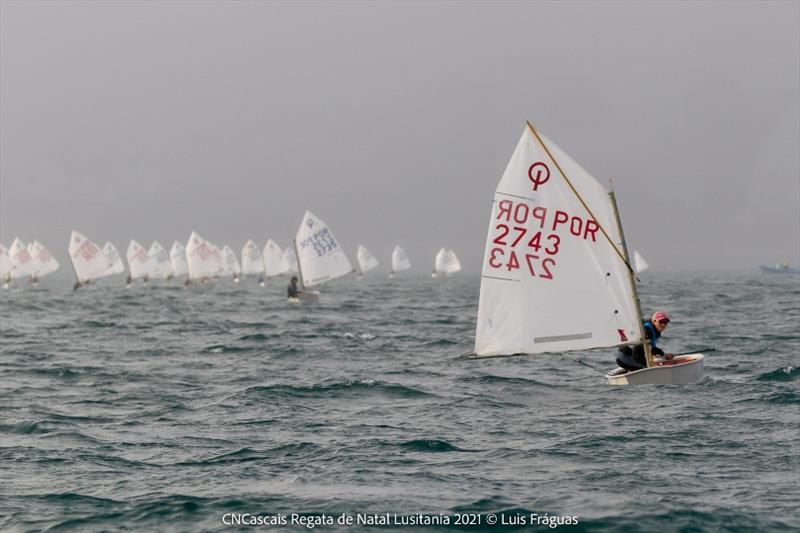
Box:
(489, 224, 561, 279)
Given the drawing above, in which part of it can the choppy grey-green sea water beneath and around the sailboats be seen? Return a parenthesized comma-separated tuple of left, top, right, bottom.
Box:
(0, 273, 800, 531)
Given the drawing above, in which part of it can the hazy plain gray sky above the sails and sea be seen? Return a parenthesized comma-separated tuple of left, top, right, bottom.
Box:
(0, 0, 800, 273)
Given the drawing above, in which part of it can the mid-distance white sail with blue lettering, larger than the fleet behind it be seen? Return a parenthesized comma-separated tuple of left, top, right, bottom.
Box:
(295, 211, 353, 287)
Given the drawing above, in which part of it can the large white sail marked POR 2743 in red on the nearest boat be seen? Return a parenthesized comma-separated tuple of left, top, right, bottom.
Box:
(475, 126, 640, 356)
